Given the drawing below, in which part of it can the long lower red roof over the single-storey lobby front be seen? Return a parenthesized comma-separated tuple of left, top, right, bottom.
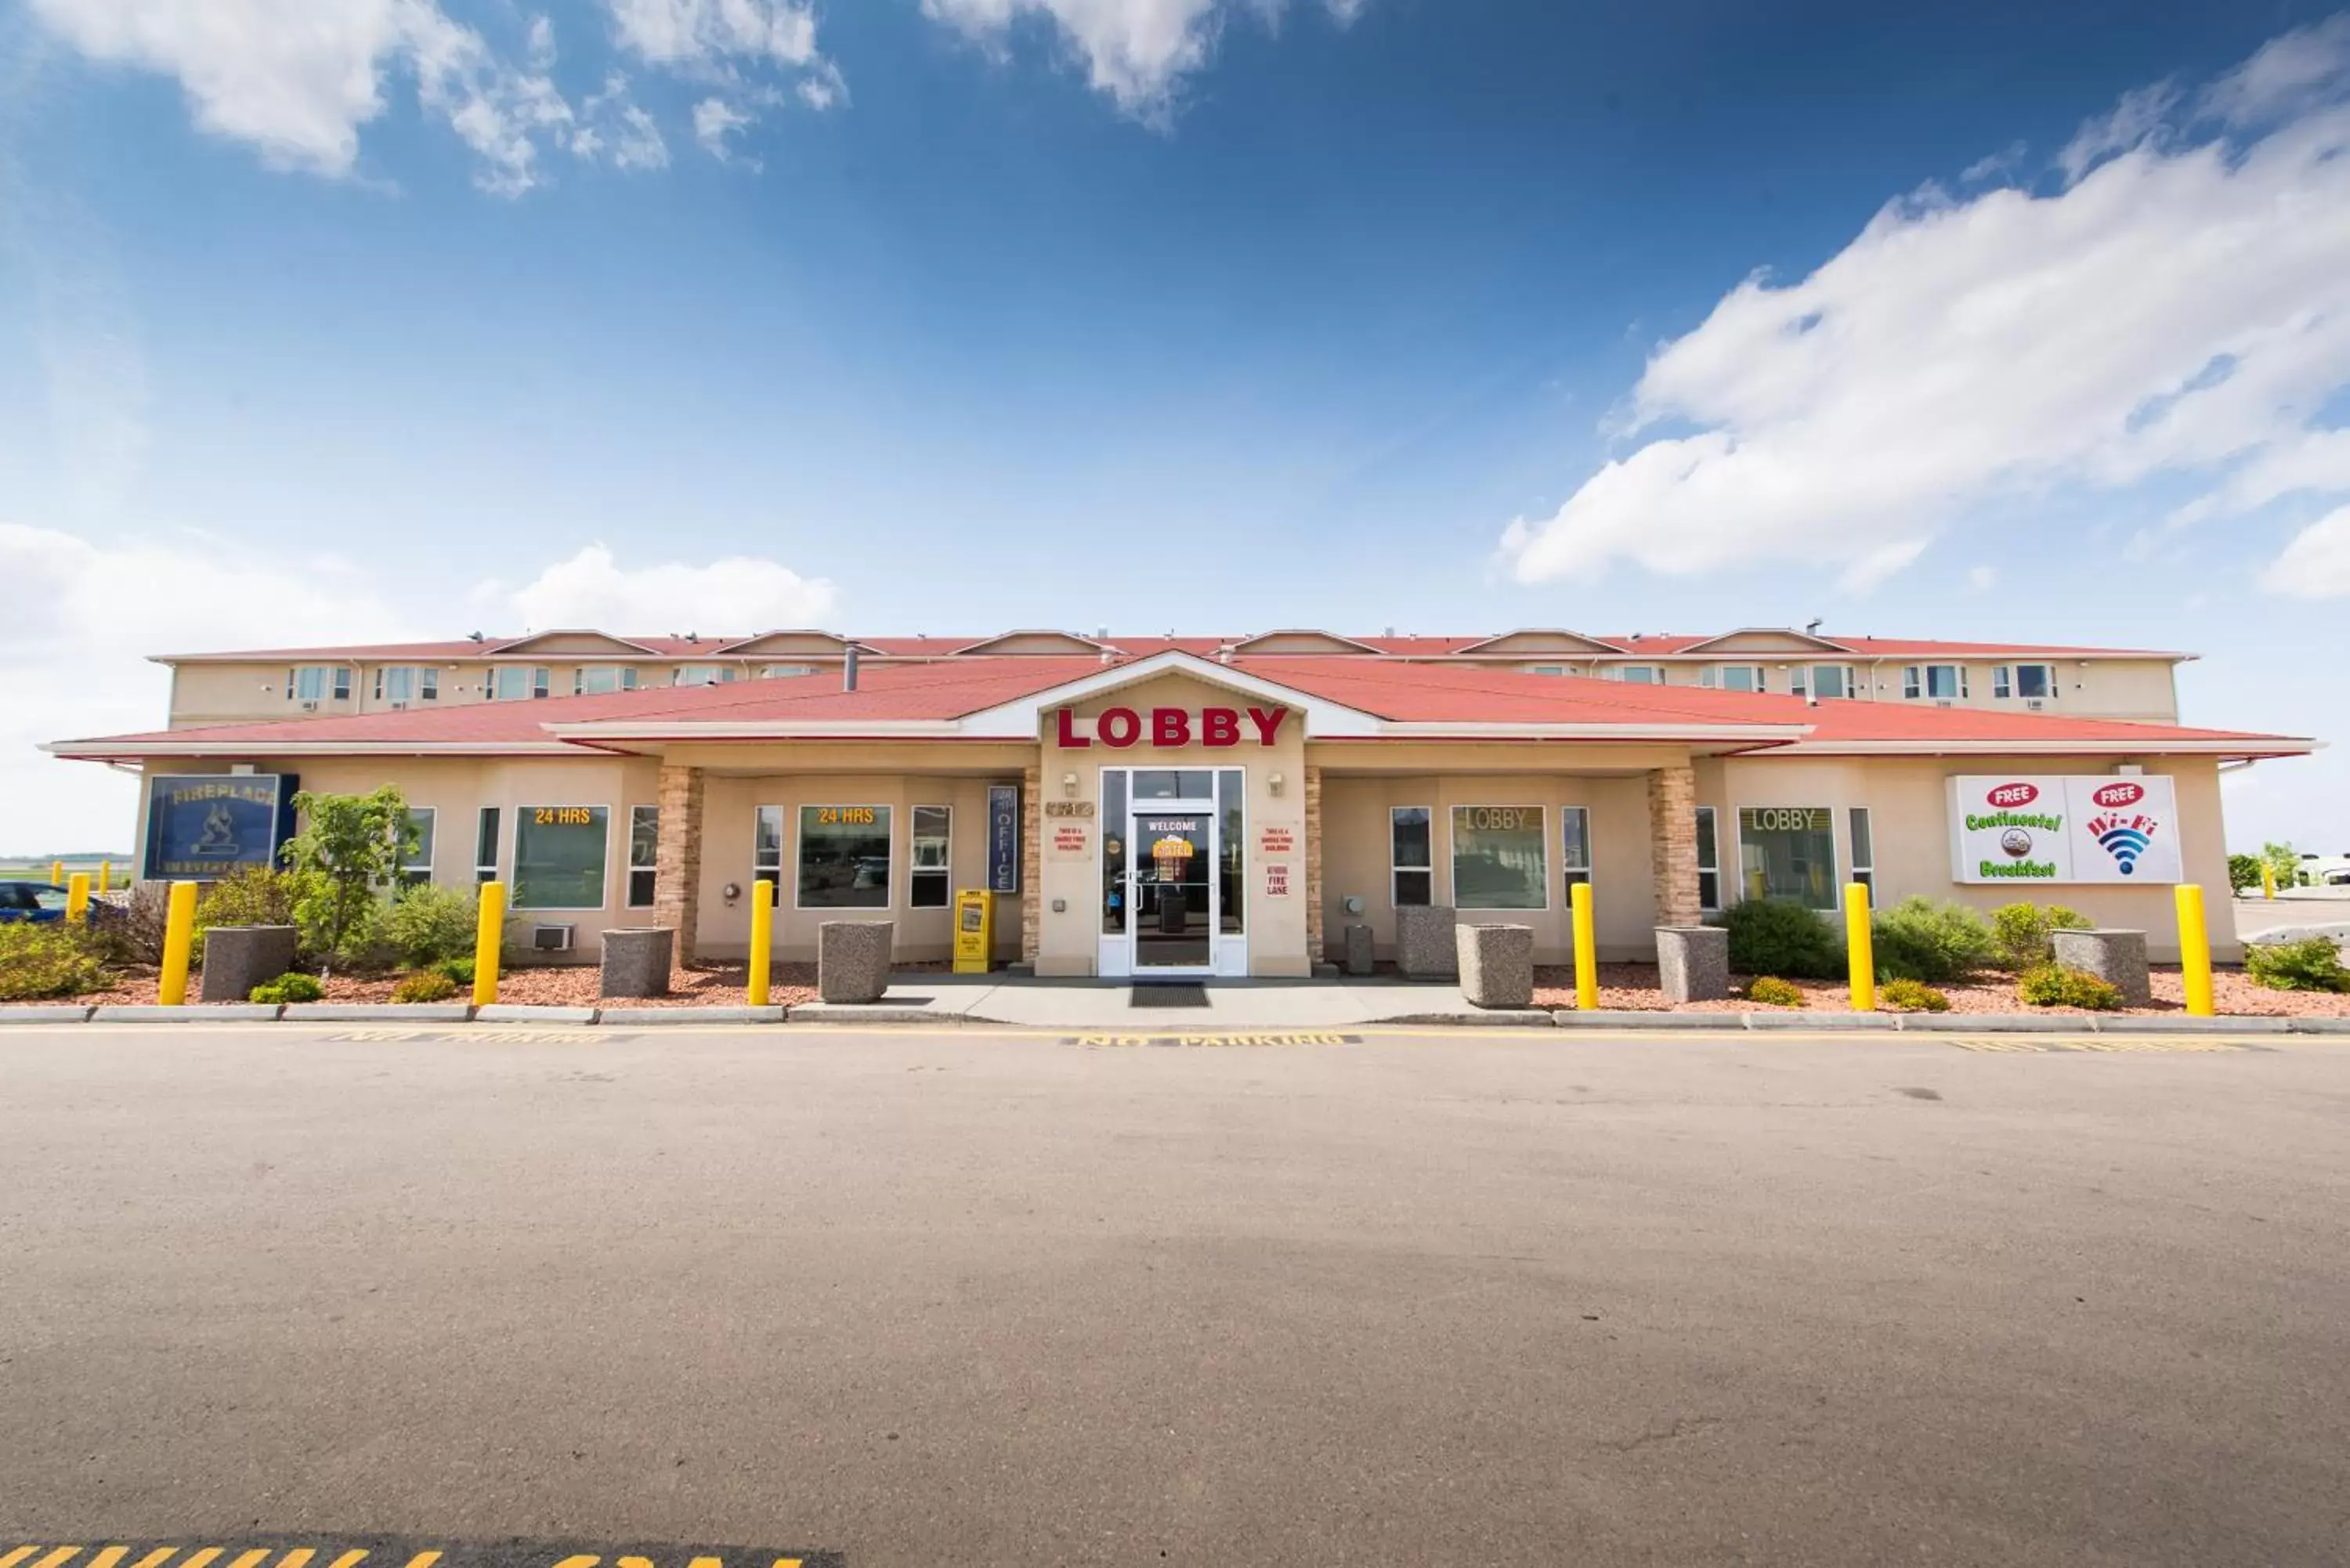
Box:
(52, 656, 2308, 757)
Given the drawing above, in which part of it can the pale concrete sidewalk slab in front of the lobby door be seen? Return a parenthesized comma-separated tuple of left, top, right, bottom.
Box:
(792, 976, 1551, 1030)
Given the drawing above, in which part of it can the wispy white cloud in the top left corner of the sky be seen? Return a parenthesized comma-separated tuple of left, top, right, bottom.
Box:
(31, 0, 585, 193)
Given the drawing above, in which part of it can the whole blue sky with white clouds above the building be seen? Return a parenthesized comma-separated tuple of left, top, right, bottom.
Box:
(0, 0, 2350, 851)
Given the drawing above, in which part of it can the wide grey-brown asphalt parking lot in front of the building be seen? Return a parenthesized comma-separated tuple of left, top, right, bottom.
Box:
(0, 1025, 2350, 1568)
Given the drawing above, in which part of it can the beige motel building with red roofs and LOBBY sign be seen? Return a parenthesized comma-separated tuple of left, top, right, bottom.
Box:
(47, 627, 2312, 978)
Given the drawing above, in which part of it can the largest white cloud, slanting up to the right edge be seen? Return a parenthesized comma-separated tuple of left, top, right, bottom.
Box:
(1502, 28, 2350, 602)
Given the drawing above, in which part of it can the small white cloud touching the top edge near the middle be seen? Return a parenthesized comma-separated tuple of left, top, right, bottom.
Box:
(921, 0, 1368, 120)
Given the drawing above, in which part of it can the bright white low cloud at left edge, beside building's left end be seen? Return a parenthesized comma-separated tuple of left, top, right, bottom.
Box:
(0, 522, 418, 854)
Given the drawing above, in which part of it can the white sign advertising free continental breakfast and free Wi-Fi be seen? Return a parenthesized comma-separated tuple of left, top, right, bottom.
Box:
(1950, 773, 2186, 884)
